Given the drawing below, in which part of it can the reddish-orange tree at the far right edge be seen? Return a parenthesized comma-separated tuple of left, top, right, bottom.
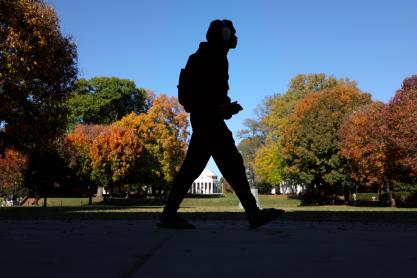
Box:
(339, 76, 417, 206)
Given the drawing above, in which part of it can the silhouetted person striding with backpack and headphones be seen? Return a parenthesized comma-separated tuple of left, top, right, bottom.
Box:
(158, 20, 283, 229)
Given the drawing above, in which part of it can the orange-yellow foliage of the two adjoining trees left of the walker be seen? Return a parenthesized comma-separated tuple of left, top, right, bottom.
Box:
(63, 95, 188, 194)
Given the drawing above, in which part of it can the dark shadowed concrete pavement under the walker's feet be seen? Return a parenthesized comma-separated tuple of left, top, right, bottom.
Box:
(0, 220, 417, 278)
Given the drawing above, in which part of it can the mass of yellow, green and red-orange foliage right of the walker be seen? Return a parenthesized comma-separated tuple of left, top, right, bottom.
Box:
(240, 74, 417, 202)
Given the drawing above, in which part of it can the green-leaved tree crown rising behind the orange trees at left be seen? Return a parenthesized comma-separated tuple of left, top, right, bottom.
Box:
(67, 77, 147, 124)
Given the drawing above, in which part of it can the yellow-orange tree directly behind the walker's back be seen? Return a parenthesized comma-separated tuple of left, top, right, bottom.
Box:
(115, 94, 188, 192)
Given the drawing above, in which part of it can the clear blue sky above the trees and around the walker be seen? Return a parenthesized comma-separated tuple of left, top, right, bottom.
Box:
(47, 0, 417, 176)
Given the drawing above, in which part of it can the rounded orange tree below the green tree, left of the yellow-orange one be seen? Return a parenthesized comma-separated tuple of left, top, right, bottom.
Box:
(63, 125, 143, 197)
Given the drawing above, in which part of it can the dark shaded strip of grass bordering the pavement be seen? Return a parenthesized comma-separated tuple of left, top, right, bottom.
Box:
(0, 206, 417, 224)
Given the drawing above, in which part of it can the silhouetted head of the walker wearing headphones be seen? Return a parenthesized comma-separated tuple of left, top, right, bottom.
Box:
(206, 19, 237, 49)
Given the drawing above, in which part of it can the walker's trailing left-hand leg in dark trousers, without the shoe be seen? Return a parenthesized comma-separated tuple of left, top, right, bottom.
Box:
(164, 133, 210, 214)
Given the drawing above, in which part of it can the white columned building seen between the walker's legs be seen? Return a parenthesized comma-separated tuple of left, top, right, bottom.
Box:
(188, 169, 223, 195)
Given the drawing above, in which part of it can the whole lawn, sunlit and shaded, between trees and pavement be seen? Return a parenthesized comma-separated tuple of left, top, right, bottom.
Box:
(0, 194, 417, 223)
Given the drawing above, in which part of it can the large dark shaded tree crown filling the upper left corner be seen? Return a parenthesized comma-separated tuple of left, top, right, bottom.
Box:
(0, 0, 77, 153)
